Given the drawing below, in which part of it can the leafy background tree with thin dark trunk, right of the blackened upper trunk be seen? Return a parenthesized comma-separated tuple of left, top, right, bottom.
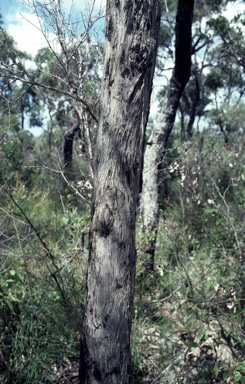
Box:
(179, 6, 245, 143)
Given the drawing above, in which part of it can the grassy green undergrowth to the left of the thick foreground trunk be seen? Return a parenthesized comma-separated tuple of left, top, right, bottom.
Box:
(0, 179, 89, 384)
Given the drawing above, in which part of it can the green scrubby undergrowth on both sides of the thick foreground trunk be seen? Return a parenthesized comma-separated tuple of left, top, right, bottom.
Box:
(0, 128, 245, 383)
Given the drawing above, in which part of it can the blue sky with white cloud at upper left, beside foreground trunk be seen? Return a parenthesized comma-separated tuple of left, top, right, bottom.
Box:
(0, 0, 106, 56)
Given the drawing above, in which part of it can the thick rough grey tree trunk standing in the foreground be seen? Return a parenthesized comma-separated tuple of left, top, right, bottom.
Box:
(80, 0, 160, 384)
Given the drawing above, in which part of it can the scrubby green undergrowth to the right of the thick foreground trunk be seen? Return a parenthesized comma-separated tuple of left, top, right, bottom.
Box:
(135, 132, 245, 384)
